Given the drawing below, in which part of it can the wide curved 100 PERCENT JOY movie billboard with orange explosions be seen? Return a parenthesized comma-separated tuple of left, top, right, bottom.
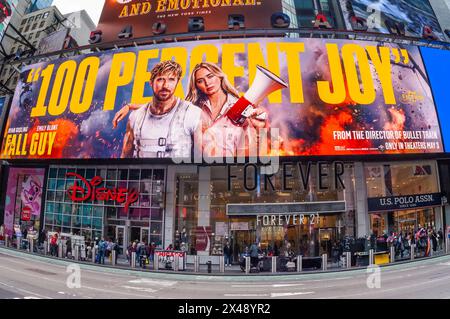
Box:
(0, 38, 443, 159)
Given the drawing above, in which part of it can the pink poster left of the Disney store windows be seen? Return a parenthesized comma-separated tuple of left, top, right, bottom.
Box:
(4, 167, 45, 236)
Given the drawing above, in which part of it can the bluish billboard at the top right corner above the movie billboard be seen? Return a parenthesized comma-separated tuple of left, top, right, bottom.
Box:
(339, 0, 445, 41)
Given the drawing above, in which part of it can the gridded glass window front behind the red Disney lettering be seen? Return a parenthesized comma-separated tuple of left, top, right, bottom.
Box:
(45, 167, 165, 246)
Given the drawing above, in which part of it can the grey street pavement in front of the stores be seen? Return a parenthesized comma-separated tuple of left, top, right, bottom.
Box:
(0, 248, 450, 299)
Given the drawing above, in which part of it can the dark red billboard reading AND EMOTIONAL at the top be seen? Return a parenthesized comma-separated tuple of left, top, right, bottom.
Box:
(97, 0, 282, 42)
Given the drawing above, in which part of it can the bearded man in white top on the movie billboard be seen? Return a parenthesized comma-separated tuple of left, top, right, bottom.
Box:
(121, 61, 201, 158)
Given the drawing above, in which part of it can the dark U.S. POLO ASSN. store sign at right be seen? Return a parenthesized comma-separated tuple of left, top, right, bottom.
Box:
(367, 193, 441, 212)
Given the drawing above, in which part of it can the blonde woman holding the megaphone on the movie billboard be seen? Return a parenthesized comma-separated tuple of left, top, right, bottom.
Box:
(113, 62, 268, 157)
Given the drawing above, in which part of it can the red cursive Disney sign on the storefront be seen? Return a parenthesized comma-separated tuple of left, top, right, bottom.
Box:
(66, 173, 139, 210)
